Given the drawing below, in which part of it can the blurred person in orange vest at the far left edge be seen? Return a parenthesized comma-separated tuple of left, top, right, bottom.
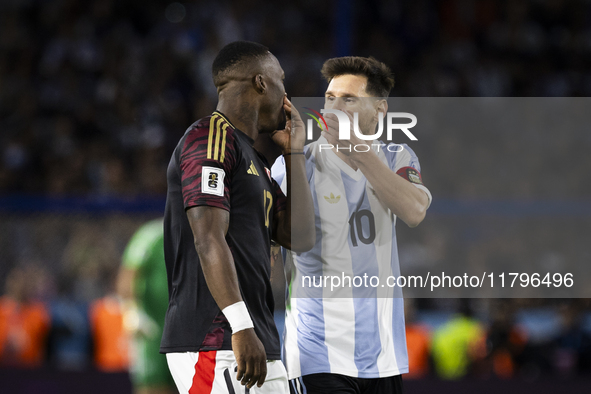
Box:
(0, 267, 50, 368)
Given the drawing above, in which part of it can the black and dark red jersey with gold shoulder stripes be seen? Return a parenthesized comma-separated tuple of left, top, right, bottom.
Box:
(160, 112, 286, 360)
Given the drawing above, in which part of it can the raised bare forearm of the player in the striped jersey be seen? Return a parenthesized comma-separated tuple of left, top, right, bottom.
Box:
(354, 152, 429, 227)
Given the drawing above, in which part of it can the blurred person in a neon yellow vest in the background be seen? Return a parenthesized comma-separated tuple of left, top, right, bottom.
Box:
(431, 299, 486, 379)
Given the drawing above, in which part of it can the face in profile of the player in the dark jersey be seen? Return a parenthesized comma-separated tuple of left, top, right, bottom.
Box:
(261, 55, 286, 132)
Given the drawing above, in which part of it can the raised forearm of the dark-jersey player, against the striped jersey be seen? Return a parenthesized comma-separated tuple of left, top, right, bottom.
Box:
(278, 154, 316, 252)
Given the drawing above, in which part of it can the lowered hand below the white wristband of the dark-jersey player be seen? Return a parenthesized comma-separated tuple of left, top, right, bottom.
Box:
(232, 328, 267, 389)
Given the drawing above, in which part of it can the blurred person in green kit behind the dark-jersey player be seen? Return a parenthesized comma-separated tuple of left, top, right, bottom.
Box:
(117, 219, 176, 394)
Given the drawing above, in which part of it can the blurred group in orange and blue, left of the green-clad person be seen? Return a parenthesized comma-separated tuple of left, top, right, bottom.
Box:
(0, 266, 132, 372)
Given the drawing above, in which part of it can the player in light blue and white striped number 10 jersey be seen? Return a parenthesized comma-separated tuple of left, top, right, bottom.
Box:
(272, 57, 431, 394)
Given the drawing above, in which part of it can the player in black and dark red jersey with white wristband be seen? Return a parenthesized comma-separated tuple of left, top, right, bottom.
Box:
(160, 41, 314, 394)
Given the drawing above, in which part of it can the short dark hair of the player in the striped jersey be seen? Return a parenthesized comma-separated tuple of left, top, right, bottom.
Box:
(321, 56, 394, 97)
